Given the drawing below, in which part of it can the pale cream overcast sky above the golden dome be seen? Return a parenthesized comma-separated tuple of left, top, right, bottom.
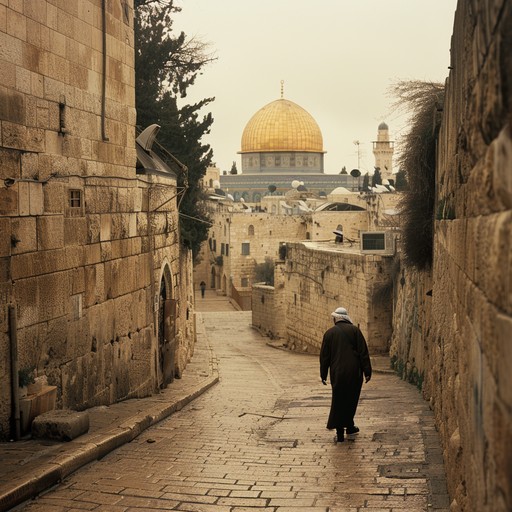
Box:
(173, 0, 457, 174)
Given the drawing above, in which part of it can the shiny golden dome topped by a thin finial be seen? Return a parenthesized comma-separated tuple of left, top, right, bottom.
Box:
(240, 98, 324, 153)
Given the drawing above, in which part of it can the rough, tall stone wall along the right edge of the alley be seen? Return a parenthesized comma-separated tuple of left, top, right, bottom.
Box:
(390, 0, 512, 512)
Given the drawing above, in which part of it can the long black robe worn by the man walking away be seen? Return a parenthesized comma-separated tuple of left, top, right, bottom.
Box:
(320, 321, 372, 429)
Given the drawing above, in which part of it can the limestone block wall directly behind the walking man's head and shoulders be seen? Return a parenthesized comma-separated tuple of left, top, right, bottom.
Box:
(284, 242, 393, 354)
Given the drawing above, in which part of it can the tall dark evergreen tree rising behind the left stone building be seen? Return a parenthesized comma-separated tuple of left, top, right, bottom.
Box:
(135, 0, 214, 257)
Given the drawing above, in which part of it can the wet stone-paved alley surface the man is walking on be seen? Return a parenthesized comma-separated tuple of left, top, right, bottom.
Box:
(14, 295, 449, 512)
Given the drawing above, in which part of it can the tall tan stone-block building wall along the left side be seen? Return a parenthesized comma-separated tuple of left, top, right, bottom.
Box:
(0, 0, 193, 437)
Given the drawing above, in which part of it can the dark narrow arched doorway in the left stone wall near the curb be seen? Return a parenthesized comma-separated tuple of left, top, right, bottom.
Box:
(158, 265, 177, 388)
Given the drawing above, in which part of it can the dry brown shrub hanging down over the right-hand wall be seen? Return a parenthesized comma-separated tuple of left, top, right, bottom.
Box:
(391, 80, 444, 270)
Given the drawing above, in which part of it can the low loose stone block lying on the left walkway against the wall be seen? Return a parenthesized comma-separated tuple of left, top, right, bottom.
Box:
(32, 409, 89, 441)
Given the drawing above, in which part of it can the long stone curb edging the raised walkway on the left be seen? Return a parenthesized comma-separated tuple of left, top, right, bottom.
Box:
(0, 372, 219, 512)
